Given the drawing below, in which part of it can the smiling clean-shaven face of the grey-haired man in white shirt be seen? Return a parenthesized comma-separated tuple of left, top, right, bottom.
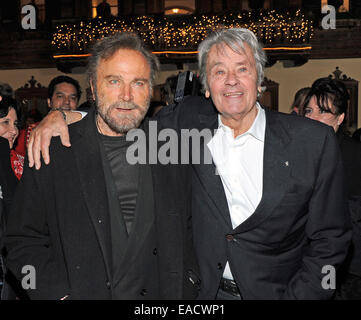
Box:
(206, 43, 260, 126)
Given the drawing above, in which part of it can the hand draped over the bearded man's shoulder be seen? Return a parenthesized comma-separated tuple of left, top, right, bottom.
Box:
(27, 111, 82, 170)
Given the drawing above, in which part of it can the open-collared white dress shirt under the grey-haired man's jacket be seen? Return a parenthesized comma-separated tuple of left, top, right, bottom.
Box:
(207, 103, 266, 279)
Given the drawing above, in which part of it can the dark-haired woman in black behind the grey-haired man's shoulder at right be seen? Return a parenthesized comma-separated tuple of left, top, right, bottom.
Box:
(304, 78, 361, 300)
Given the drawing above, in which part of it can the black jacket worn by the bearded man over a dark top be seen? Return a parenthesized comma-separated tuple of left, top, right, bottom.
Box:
(6, 112, 197, 299)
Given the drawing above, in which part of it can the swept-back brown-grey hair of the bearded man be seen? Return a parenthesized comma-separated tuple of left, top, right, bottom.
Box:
(87, 32, 159, 87)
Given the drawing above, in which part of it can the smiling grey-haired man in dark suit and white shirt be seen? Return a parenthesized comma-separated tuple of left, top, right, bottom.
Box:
(159, 29, 351, 300)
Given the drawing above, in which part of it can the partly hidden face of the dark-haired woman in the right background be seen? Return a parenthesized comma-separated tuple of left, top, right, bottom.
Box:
(304, 96, 345, 132)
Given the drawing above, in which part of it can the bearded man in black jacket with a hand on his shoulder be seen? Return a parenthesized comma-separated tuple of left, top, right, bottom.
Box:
(5, 33, 199, 300)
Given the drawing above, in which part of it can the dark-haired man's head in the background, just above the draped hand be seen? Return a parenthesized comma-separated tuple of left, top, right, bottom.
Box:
(48, 76, 81, 110)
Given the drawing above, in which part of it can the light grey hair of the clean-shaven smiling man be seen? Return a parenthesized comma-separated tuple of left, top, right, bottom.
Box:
(198, 28, 267, 90)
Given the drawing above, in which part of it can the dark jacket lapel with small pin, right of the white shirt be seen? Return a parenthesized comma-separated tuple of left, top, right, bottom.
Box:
(233, 109, 292, 233)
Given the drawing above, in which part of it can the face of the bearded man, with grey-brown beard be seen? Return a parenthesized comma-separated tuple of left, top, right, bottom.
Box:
(92, 49, 151, 136)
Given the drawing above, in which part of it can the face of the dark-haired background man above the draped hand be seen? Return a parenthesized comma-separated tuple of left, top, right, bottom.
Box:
(48, 82, 78, 110)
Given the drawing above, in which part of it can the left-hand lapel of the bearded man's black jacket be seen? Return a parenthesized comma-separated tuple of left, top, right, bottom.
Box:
(72, 112, 112, 279)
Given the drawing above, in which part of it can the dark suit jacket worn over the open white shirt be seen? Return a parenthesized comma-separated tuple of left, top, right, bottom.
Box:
(159, 97, 351, 299)
